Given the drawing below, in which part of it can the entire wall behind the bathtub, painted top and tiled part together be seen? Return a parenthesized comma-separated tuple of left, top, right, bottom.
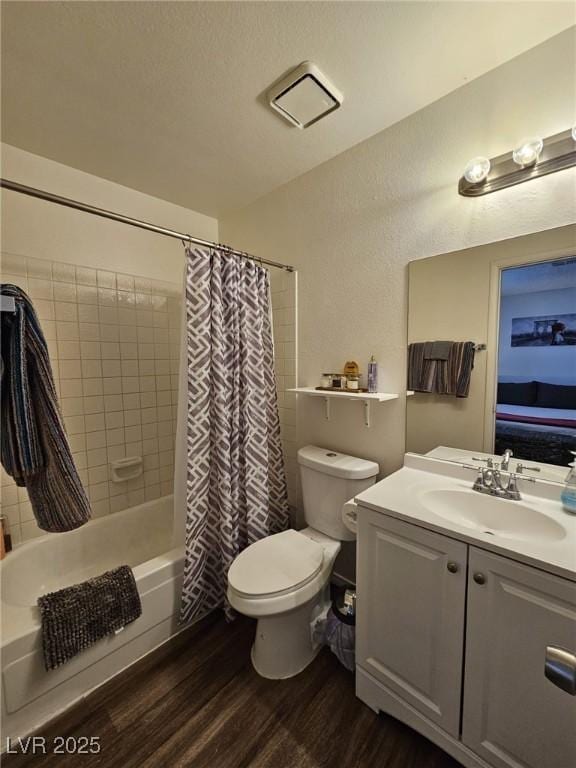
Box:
(1, 145, 218, 544)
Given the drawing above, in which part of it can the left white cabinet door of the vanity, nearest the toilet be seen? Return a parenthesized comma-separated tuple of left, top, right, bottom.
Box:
(356, 509, 467, 736)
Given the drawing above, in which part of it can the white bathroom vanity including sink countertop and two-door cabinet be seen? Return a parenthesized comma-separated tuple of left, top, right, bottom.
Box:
(356, 454, 576, 768)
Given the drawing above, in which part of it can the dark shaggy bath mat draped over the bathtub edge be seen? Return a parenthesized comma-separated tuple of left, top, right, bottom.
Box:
(38, 565, 142, 670)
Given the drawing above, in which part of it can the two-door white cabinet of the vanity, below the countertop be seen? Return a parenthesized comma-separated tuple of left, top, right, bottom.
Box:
(356, 508, 576, 768)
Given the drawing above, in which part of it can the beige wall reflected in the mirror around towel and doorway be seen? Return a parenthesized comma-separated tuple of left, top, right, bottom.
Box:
(406, 226, 576, 460)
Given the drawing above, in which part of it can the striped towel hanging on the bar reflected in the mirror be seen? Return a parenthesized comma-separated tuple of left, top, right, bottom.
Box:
(408, 341, 474, 397)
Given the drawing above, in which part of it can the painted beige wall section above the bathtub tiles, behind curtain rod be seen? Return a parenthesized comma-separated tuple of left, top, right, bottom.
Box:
(0, 144, 218, 282)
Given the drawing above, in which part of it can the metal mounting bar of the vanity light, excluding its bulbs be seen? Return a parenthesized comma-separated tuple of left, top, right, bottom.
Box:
(458, 129, 576, 197)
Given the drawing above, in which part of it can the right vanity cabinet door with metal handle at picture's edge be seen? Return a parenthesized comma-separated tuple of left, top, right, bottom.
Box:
(462, 548, 576, 768)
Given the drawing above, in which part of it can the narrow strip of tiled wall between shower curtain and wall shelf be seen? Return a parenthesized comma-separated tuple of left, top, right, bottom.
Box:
(270, 269, 299, 522)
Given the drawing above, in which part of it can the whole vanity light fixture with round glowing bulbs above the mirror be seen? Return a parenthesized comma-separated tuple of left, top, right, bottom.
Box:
(458, 126, 576, 197)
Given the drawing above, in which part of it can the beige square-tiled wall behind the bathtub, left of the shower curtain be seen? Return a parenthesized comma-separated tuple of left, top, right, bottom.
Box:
(1, 253, 182, 544)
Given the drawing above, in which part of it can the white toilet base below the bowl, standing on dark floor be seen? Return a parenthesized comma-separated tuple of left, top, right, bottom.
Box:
(251, 585, 330, 680)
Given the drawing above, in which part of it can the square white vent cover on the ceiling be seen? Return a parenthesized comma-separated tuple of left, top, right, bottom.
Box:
(268, 61, 343, 128)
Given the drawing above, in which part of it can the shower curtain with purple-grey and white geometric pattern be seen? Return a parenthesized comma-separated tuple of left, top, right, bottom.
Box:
(181, 249, 289, 621)
